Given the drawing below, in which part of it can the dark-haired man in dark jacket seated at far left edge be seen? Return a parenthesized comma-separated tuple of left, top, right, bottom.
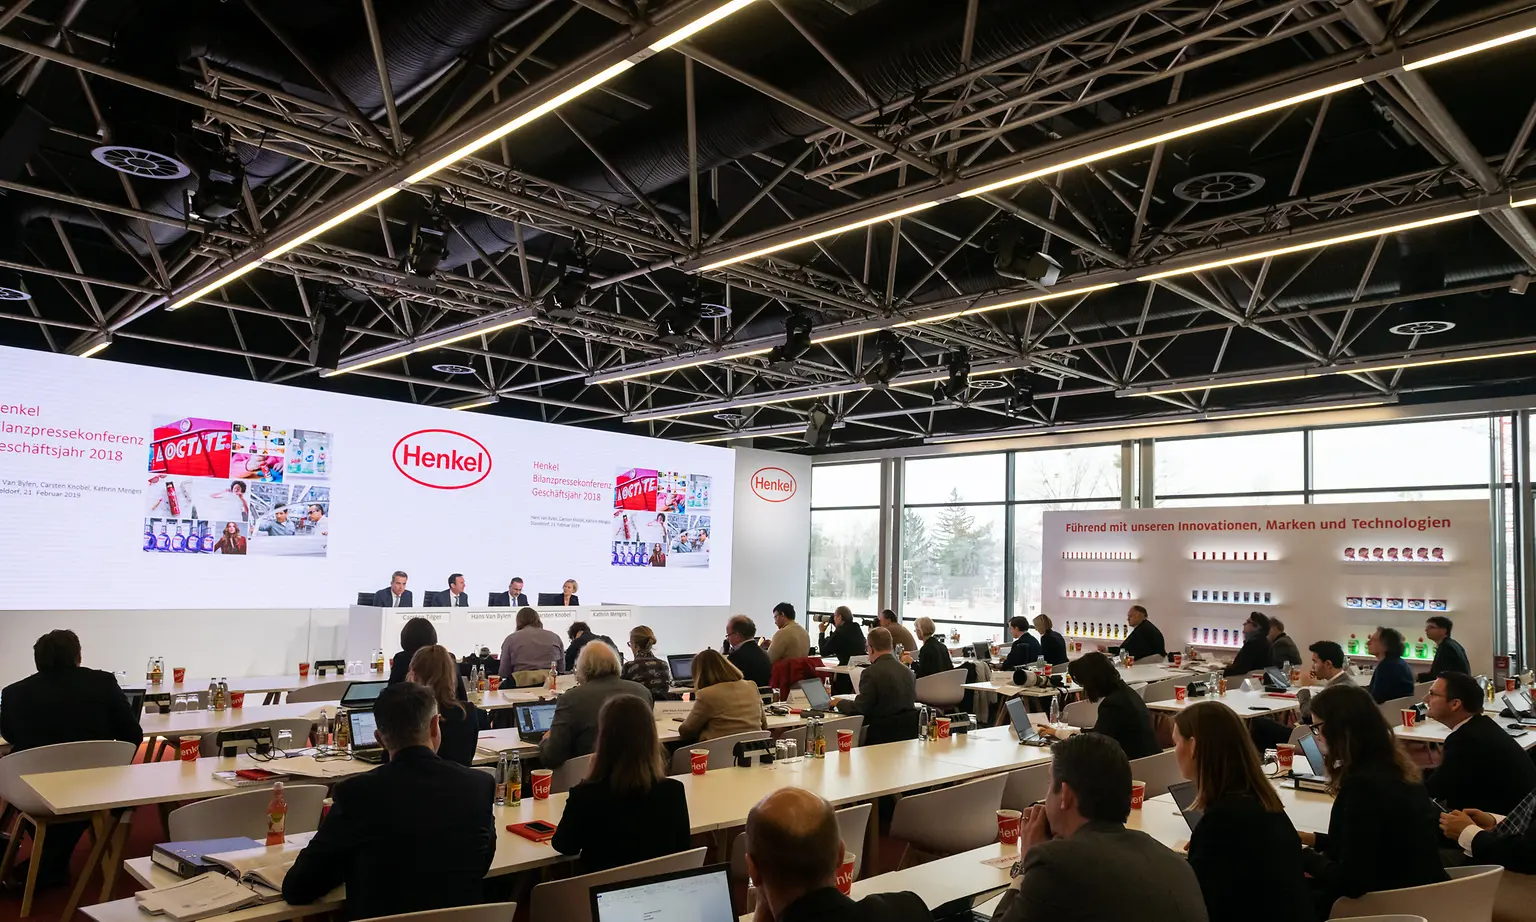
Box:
(0, 630, 144, 890)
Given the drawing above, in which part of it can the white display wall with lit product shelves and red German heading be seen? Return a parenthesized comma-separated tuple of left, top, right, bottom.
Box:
(1041, 501, 1493, 672)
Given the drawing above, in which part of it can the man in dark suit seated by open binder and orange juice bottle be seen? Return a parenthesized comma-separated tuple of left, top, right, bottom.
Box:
(283, 682, 496, 919)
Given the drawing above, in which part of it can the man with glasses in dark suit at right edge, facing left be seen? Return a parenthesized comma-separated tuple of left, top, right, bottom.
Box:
(1424, 673, 1536, 814)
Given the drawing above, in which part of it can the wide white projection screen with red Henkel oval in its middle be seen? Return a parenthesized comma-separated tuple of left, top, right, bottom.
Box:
(0, 347, 734, 609)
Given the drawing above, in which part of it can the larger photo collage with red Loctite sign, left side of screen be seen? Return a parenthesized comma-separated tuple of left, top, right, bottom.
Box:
(141, 413, 335, 556)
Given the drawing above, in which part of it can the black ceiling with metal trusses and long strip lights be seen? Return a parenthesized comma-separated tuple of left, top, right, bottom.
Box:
(0, 0, 1536, 450)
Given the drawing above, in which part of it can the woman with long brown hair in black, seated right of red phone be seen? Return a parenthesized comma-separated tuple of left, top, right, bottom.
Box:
(550, 695, 691, 874)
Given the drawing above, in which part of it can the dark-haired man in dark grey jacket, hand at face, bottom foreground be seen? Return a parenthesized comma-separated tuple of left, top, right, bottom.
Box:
(992, 733, 1204, 922)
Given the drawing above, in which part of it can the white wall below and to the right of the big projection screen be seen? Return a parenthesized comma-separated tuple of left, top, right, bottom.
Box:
(0, 449, 811, 685)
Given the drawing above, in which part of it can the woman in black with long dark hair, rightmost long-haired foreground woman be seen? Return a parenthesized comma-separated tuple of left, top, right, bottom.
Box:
(1296, 685, 1447, 919)
